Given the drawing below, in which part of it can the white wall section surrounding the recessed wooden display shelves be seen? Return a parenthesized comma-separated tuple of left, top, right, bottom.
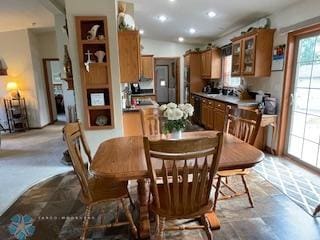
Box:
(65, 0, 123, 153)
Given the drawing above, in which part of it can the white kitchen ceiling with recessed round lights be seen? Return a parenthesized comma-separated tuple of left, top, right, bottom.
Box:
(127, 0, 299, 43)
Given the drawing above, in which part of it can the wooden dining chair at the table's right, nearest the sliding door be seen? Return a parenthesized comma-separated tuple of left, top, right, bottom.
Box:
(213, 107, 262, 209)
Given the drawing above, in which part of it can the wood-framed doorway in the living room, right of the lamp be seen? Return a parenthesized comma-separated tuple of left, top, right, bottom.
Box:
(43, 59, 67, 124)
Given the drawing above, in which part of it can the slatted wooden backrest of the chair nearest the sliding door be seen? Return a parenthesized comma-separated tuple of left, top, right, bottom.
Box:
(225, 107, 262, 145)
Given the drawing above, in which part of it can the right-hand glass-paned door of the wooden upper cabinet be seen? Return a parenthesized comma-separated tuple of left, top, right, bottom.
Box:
(241, 35, 256, 75)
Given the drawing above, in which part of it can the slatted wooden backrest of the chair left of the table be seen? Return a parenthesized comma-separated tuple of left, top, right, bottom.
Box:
(63, 122, 92, 200)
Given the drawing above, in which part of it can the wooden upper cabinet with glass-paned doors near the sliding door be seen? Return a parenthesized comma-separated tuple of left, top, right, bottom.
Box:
(231, 29, 275, 77)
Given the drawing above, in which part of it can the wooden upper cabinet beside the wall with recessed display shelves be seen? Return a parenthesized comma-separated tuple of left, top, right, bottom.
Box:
(118, 31, 141, 83)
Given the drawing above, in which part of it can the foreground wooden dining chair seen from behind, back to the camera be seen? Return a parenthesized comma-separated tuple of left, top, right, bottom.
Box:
(144, 133, 223, 239)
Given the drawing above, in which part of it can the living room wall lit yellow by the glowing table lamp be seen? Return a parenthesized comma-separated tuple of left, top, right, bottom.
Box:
(0, 30, 41, 127)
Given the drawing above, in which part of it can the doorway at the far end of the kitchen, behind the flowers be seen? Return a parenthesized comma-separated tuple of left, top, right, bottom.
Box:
(154, 58, 180, 104)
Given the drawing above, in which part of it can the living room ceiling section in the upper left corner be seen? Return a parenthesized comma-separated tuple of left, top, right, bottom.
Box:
(0, 0, 54, 32)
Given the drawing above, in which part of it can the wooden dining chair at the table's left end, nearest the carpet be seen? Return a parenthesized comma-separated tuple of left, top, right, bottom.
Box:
(63, 122, 137, 240)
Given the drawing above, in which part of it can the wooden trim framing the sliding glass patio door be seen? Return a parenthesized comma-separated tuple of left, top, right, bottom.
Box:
(276, 24, 320, 155)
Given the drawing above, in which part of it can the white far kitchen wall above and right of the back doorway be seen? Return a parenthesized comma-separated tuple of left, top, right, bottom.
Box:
(141, 38, 201, 102)
